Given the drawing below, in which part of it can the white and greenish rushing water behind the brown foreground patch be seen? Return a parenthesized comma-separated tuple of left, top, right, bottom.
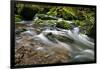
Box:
(15, 20, 94, 62)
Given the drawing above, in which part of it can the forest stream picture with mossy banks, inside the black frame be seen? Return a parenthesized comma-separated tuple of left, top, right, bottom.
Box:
(14, 3, 95, 66)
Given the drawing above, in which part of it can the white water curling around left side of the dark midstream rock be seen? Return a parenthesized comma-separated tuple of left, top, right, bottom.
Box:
(33, 29, 72, 52)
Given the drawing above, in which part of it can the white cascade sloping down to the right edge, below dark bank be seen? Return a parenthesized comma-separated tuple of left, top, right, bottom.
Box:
(57, 27, 94, 49)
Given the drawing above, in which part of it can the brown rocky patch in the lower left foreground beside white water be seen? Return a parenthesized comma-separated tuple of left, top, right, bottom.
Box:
(15, 22, 70, 66)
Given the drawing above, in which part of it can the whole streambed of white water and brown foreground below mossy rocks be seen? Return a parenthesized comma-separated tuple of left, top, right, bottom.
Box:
(15, 19, 94, 66)
